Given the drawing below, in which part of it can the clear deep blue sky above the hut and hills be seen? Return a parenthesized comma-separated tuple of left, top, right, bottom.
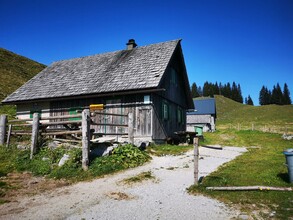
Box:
(0, 0, 293, 105)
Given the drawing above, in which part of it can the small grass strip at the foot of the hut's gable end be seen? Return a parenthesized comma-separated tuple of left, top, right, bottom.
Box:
(147, 144, 193, 156)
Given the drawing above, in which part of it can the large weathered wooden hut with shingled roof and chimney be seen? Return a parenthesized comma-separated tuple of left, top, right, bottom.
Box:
(2, 39, 194, 142)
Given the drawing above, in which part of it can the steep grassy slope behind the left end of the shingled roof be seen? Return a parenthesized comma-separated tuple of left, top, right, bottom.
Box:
(0, 48, 46, 101)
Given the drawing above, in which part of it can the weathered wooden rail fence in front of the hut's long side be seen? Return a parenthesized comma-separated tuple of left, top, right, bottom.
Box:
(0, 109, 134, 170)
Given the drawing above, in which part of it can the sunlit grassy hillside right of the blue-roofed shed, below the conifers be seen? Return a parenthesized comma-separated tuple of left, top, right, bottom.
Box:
(215, 95, 293, 132)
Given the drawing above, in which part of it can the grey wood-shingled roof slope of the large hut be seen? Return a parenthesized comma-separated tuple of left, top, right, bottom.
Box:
(2, 40, 180, 103)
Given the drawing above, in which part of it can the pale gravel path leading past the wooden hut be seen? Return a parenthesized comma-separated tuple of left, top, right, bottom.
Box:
(0, 147, 246, 220)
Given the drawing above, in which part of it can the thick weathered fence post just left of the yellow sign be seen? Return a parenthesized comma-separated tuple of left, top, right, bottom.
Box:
(81, 109, 90, 171)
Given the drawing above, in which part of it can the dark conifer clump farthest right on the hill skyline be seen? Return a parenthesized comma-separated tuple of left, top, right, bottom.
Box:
(259, 83, 292, 105)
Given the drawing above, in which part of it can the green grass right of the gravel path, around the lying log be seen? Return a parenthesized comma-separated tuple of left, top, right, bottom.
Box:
(189, 130, 293, 219)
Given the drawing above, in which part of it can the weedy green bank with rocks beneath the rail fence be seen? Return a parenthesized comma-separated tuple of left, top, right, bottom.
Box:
(0, 145, 151, 204)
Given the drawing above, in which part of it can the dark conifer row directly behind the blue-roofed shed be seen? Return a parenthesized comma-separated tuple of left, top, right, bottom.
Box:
(190, 82, 245, 104)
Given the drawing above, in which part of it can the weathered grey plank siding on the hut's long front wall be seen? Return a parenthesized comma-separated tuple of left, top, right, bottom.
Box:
(50, 94, 161, 141)
